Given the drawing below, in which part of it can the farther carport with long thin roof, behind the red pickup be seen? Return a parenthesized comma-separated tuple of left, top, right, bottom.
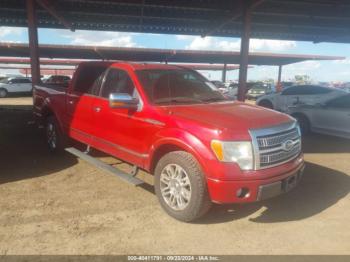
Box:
(0, 43, 345, 82)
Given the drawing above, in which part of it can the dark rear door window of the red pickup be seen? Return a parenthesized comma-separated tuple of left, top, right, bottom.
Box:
(74, 65, 107, 95)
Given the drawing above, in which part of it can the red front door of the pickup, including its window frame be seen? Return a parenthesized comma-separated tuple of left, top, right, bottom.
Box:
(92, 67, 160, 166)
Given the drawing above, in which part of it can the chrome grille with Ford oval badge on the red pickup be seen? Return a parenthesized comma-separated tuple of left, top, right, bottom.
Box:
(250, 122, 301, 169)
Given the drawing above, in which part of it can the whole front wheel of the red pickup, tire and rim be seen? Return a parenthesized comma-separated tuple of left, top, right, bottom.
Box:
(155, 151, 211, 222)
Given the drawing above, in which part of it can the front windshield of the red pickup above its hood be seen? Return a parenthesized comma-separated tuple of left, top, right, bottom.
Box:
(136, 68, 227, 104)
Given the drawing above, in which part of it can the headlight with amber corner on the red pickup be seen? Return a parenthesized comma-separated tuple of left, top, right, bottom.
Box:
(211, 140, 254, 170)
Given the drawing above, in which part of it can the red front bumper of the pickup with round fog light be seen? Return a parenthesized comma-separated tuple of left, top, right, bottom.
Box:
(207, 162, 305, 204)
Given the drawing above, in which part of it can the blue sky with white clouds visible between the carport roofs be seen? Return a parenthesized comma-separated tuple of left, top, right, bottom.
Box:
(0, 27, 350, 82)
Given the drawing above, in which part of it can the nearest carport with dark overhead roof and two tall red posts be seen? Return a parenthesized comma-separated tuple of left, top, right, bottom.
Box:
(0, 0, 350, 100)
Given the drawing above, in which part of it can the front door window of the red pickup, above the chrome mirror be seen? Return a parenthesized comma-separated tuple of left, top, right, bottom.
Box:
(101, 68, 135, 98)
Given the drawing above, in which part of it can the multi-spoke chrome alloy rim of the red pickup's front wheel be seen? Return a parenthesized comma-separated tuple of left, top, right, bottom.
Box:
(160, 164, 192, 210)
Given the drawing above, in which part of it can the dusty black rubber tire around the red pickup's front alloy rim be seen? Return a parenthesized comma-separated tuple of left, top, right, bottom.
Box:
(155, 151, 212, 222)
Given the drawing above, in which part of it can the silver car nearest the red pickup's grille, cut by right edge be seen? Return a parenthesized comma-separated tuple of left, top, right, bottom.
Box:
(290, 94, 350, 139)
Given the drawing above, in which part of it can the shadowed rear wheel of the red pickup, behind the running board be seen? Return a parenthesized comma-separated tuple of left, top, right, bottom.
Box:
(45, 116, 67, 153)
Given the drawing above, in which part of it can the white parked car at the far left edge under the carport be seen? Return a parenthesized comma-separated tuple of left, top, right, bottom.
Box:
(0, 77, 32, 98)
